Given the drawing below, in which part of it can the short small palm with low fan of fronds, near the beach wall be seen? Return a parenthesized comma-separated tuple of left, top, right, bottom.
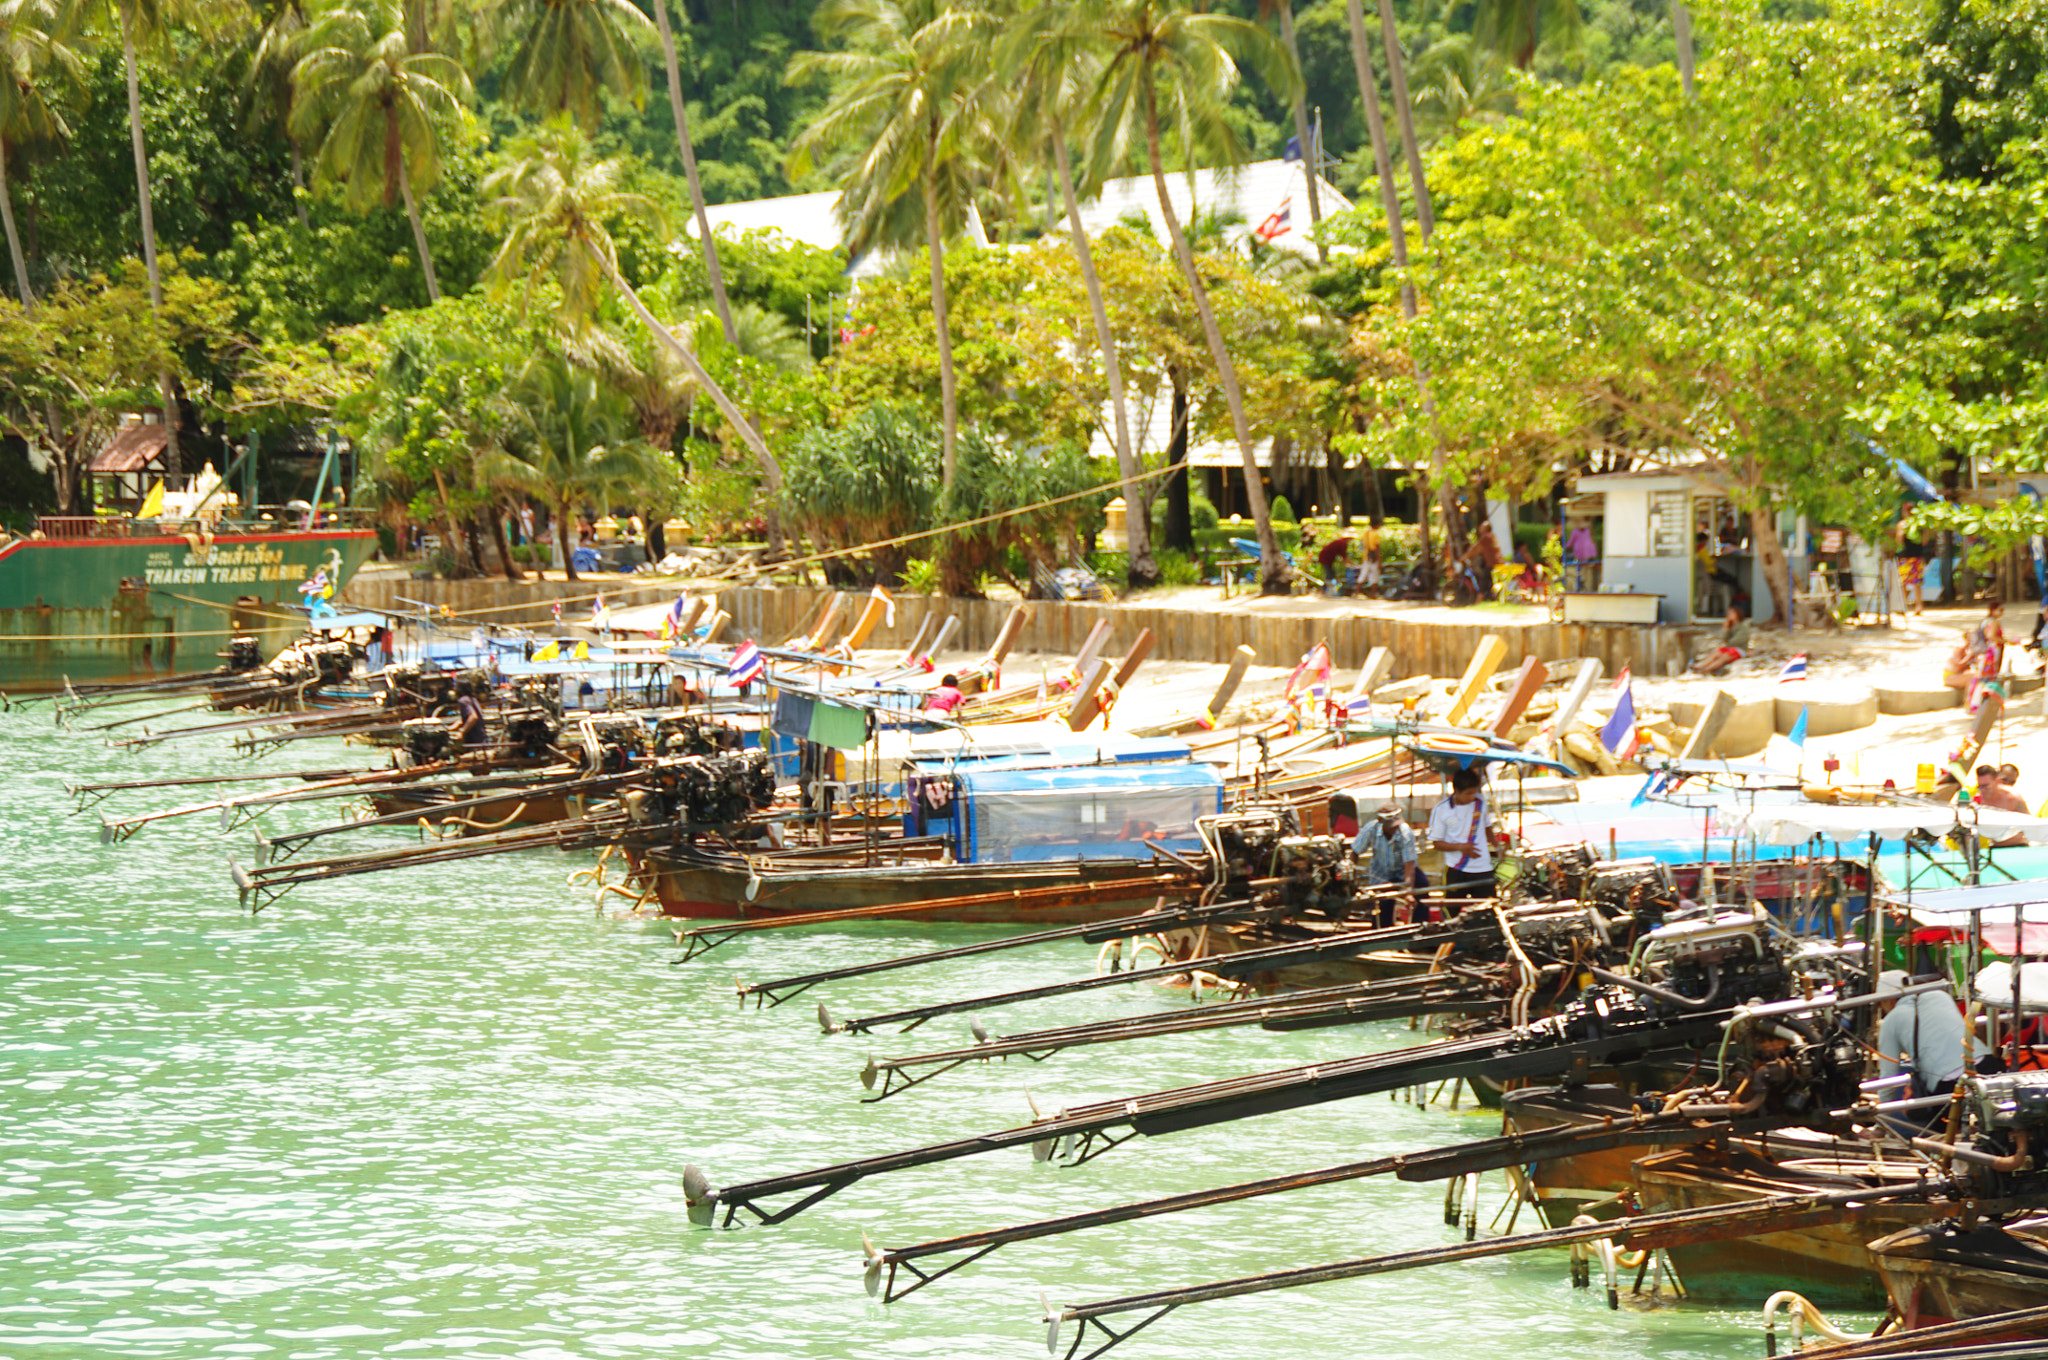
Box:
(477, 350, 664, 582)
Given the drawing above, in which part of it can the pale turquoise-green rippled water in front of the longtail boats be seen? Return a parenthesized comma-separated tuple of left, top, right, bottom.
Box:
(0, 707, 1870, 1360)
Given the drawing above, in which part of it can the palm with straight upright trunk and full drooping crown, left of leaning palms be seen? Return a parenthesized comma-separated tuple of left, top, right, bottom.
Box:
(788, 0, 993, 487)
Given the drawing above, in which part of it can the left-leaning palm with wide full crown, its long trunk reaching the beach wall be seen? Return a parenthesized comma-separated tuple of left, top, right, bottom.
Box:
(1040, 0, 1300, 594)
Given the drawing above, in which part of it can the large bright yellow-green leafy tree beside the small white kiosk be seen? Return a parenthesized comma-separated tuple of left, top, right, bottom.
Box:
(1380, 6, 1954, 612)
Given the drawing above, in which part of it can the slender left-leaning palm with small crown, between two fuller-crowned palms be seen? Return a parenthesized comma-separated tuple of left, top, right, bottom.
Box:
(993, 12, 1159, 588)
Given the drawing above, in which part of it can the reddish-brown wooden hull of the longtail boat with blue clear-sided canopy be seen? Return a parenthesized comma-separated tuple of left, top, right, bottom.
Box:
(639, 850, 1187, 926)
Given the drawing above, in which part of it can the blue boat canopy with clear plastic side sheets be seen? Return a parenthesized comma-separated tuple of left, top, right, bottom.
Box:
(950, 760, 1223, 864)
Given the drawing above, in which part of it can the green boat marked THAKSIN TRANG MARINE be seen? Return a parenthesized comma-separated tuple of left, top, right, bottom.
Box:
(0, 516, 377, 694)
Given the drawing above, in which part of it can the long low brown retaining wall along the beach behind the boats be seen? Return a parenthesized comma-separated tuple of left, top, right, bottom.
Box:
(344, 578, 1686, 680)
